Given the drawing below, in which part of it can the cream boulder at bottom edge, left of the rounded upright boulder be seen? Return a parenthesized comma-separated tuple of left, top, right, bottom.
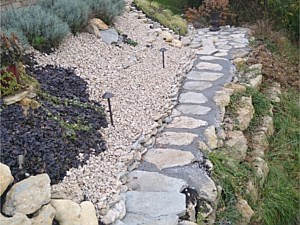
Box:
(51, 199, 81, 225)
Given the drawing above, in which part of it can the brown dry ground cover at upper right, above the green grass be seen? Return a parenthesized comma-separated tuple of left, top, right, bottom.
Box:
(248, 21, 300, 90)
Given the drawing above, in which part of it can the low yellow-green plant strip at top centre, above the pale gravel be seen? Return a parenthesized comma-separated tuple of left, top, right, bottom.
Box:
(134, 0, 187, 35)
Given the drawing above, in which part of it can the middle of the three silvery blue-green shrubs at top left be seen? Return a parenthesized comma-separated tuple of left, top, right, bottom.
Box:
(39, 0, 90, 34)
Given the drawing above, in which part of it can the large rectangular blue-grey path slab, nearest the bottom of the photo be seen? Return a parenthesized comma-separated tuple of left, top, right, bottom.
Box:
(125, 191, 186, 217)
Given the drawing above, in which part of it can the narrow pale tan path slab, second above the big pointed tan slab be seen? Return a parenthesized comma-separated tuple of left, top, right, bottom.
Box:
(167, 116, 207, 129)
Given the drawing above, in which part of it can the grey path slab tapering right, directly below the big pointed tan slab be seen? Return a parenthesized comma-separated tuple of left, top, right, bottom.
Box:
(126, 170, 188, 192)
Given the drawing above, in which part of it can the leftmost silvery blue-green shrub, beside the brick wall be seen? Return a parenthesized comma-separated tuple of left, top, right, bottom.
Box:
(1, 5, 69, 50)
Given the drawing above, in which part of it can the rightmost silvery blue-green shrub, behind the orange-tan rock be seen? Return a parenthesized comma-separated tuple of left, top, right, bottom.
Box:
(86, 0, 125, 23)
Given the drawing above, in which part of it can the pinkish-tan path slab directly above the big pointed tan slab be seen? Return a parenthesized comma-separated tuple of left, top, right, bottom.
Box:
(156, 132, 198, 146)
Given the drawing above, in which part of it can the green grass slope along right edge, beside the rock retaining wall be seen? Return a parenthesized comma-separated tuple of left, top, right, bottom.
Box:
(256, 91, 300, 225)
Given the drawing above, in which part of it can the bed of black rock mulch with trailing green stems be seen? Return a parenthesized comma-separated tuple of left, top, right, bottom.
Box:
(0, 66, 107, 184)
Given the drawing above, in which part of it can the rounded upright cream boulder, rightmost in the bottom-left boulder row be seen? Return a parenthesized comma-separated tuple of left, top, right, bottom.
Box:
(80, 201, 98, 225)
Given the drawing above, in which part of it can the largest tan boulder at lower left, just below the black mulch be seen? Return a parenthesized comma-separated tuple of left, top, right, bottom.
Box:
(3, 174, 51, 216)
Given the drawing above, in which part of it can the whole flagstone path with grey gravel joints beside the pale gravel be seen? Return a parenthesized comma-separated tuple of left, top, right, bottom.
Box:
(119, 27, 249, 225)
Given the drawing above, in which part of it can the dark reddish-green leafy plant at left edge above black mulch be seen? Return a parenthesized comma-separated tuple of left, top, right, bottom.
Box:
(0, 33, 23, 67)
